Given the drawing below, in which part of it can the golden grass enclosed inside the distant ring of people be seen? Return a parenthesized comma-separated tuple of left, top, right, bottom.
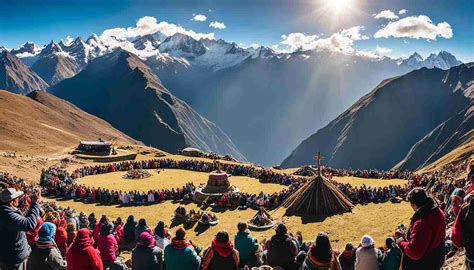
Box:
(78, 169, 285, 194)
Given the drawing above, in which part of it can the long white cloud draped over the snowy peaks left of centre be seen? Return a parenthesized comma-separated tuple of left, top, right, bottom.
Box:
(100, 16, 214, 45)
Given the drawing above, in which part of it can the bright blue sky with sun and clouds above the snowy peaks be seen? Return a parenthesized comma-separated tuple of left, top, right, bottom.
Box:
(0, 0, 474, 62)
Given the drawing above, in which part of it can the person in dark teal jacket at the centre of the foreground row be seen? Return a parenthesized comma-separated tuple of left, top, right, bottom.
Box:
(234, 222, 261, 268)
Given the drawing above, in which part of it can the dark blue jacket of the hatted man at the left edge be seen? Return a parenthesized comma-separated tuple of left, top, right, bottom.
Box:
(0, 202, 40, 265)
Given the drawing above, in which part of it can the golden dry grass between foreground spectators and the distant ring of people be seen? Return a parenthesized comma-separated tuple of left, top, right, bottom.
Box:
(51, 197, 412, 250)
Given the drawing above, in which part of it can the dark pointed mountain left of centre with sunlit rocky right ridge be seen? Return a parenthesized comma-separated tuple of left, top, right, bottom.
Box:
(50, 49, 245, 160)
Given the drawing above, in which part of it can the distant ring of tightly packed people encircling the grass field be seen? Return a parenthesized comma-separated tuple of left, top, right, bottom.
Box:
(40, 159, 418, 209)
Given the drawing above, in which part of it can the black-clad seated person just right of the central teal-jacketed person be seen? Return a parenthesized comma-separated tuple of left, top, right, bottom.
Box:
(265, 224, 299, 270)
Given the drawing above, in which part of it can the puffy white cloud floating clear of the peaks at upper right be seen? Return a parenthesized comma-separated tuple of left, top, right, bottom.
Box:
(374, 15, 453, 40)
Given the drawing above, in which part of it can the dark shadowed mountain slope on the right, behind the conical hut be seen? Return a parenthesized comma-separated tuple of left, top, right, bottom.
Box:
(282, 63, 474, 169)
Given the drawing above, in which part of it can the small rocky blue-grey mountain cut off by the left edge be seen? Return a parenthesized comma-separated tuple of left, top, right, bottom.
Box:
(0, 50, 48, 94)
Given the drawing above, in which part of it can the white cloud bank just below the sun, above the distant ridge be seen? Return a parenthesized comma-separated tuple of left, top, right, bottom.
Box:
(280, 26, 369, 54)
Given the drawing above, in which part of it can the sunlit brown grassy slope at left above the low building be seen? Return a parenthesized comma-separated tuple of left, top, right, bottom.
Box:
(0, 90, 141, 155)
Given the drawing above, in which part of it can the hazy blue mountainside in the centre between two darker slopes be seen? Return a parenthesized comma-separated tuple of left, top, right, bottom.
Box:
(150, 51, 409, 165)
